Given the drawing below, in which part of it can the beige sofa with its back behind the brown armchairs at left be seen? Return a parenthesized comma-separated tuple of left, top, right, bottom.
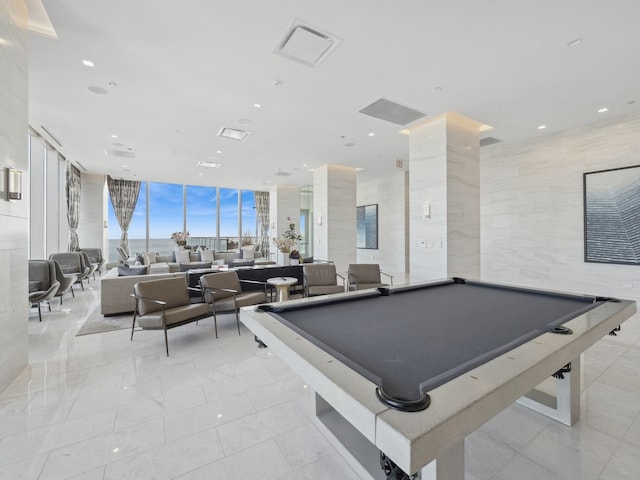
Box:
(100, 267, 186, 315)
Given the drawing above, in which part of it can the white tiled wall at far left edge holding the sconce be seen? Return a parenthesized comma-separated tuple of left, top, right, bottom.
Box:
(0, 0, 29, 391)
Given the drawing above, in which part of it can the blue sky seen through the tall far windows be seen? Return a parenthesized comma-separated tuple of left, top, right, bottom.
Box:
(109, 182, 256, 239)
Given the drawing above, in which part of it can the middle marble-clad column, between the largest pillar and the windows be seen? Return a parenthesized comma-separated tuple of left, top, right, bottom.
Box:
(313, 165, 356, 274)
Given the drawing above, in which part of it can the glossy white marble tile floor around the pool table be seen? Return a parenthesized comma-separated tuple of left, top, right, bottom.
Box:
(0, 281, 640, 480)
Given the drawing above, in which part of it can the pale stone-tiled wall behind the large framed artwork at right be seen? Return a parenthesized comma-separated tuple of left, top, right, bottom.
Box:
(480, 115, 640, 300)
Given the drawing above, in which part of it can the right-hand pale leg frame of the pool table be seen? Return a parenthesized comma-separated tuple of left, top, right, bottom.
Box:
(518, 357, 580, 426)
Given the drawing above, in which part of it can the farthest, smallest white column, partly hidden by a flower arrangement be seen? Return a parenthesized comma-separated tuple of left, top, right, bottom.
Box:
(269, 185, 300, 261)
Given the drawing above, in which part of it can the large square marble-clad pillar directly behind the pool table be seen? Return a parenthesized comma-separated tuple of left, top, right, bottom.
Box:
(409, 112, 482, 282)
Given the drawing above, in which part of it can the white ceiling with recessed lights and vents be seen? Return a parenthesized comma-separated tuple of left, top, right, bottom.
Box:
(29, 0, 640, 190)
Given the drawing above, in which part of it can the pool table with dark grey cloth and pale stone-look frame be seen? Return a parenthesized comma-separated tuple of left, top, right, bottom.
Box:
(241, 278, 636, 480)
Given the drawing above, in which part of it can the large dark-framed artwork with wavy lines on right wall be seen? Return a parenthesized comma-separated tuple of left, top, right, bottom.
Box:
(583, 165, 640, 265)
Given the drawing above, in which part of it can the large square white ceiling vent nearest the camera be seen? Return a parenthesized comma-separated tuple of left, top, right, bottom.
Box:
(274, 19, 342, 67)
